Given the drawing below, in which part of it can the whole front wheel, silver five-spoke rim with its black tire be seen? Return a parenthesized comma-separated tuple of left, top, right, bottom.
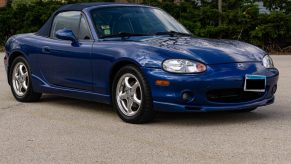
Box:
(112, 65, 155, 124)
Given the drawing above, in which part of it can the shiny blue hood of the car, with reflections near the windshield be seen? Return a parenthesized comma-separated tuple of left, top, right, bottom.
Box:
(139, 36, 266, 64)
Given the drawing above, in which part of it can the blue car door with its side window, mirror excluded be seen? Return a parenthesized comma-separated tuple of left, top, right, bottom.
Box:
(41, 11, 93, 90)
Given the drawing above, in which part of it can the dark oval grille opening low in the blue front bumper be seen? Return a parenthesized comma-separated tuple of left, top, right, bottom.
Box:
(207, 89, 265, 103)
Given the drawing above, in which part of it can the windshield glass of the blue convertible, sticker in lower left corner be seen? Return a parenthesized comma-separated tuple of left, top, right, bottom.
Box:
(91, 6, 190, 38)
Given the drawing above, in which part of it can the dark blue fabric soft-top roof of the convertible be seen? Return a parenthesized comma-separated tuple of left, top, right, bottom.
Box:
(36, 2, 146, 37)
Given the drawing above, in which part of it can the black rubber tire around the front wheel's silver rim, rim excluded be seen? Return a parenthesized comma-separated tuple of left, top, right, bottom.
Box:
(112, 65, 155, 124)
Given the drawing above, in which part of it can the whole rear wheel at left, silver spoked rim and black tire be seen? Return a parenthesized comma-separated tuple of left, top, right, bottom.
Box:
(9, 57, 41, 102)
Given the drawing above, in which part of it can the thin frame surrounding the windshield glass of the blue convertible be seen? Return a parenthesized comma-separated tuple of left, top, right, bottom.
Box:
(87, 4, 193, 39)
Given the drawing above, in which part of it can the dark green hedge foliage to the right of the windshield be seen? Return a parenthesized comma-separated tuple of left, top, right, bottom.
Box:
(144, 0, 291, 51)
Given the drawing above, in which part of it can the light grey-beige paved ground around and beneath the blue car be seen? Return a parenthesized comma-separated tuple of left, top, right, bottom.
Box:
(0, 54, 291, 163)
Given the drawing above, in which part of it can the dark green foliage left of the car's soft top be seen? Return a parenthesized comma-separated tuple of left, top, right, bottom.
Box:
(0, 1, 62, 45)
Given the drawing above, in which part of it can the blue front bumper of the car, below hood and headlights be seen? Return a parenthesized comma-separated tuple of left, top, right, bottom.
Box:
(143, 62, 279, 112)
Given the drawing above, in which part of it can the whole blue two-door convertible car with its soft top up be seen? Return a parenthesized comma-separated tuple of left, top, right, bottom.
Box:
(4, 3, 279, 123)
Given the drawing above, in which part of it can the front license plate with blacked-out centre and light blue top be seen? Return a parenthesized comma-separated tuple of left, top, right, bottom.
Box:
(244, 75, 267, 92)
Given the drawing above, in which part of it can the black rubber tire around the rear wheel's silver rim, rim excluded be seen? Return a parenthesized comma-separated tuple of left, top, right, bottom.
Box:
(9, 56, 42, 102)
